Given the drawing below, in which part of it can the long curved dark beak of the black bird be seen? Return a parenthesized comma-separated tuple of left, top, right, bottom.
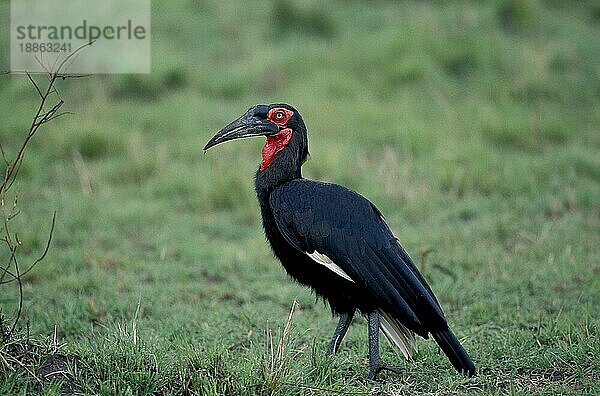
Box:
(204, 105, 279, 151)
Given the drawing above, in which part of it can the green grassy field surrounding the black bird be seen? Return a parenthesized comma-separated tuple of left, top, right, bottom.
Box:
(0, 0, 600, 395)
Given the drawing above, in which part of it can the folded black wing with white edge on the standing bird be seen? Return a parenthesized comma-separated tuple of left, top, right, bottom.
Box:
(269, 179, 447, 336)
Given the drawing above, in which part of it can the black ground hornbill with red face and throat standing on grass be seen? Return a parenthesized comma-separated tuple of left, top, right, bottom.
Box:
(204, 103, 475, 379)
